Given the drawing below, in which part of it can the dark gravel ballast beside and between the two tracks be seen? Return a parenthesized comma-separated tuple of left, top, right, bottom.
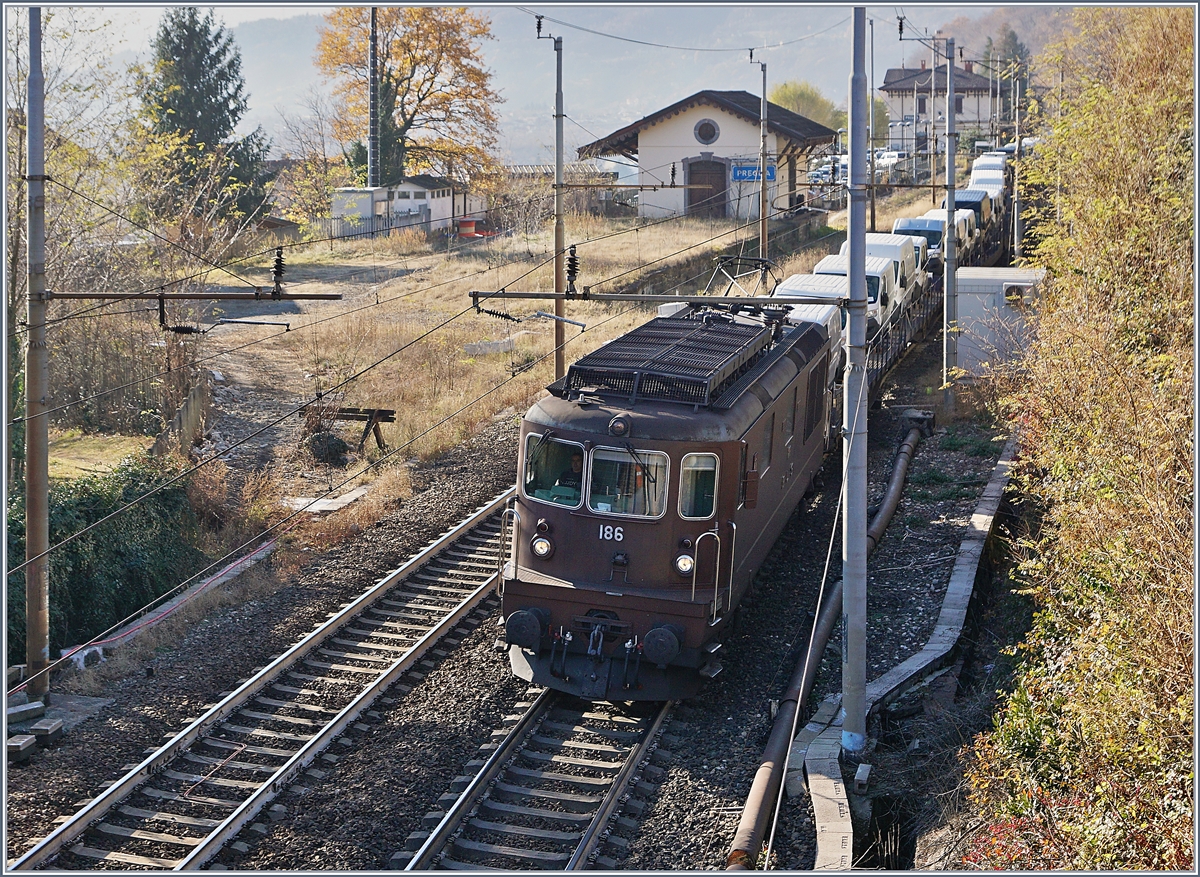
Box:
(7, 341, 1000, 870)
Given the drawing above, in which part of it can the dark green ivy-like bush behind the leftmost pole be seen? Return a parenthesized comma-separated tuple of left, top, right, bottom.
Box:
(7, 456, 206, 663)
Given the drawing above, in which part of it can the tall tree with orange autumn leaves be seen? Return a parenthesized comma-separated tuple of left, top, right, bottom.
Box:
(316, 6, 503, 185)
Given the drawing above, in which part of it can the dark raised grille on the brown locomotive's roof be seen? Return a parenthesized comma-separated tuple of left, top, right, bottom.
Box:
(550, 317, 772, 406)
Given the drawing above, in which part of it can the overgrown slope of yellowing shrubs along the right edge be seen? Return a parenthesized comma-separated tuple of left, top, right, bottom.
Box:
(965, 8, 1195, 870)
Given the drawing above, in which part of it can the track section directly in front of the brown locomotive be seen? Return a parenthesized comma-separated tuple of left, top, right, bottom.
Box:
(405, 689, 673, 871)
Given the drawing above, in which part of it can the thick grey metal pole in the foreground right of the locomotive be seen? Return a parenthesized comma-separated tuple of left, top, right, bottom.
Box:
(841, 6, 866, 752)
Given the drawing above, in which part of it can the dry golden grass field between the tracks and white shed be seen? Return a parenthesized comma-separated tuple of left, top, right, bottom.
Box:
(272, 216, 744, 458)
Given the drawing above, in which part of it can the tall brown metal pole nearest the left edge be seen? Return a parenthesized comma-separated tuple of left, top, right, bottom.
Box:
(25, 6, 50, 699)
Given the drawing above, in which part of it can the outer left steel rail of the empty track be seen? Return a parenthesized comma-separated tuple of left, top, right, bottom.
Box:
(10, 487, 516, 871)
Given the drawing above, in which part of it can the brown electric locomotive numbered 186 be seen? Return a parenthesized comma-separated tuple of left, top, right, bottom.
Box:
(502, 306, 838, 701)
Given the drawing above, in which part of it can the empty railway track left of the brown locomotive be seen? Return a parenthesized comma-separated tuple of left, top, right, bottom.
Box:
(10, 489, 512, 870)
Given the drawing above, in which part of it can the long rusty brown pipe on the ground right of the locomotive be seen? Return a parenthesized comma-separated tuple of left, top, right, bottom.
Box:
(725, 426, 928, 871)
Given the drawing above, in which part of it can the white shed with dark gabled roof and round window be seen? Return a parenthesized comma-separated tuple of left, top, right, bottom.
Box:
(578, 90, 836, 220)
